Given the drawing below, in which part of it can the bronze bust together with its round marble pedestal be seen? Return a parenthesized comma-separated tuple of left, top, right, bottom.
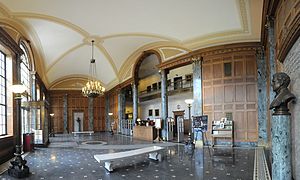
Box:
(270, 72, 296, 180)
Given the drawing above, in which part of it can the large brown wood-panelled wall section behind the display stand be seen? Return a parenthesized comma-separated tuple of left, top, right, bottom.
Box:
(203, 51, 258, 142)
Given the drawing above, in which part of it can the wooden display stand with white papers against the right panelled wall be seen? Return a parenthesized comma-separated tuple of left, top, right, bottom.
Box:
(211, 118, 234, 147)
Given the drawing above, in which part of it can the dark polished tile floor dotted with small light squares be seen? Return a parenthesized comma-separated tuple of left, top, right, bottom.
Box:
(0, 133, 255, 180)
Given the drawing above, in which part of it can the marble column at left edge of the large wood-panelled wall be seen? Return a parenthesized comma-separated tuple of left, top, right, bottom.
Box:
(191, 57, 203, 144)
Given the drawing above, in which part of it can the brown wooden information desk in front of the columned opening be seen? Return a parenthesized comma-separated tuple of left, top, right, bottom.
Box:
(133, 126, 157, 141)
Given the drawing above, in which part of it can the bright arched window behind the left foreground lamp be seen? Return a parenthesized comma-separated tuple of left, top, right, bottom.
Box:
(20, 43, 32, 134)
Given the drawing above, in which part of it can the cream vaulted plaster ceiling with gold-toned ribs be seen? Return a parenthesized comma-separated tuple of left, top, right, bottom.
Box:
(0, 0, 263, 89)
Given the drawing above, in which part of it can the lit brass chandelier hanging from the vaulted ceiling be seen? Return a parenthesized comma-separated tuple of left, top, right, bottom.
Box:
(82, 40, 105, 98)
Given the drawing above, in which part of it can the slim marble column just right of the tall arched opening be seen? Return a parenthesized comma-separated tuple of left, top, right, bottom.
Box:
(160, 69, 168, 140)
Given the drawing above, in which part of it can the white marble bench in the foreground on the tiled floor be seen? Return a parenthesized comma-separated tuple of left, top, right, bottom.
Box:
(94, 146, 163, 172)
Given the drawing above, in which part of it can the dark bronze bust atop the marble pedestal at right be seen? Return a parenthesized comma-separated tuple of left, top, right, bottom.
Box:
(270, 72, 296, 115)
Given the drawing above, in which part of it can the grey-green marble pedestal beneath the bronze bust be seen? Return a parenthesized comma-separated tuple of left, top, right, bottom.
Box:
(271, 115, 292, 180)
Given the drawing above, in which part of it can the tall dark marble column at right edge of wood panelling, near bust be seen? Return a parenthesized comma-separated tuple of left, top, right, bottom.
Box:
(256, 48, 268, 146)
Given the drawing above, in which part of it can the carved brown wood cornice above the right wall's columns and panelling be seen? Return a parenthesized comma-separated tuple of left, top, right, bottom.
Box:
(157, 42, 261, 70)
